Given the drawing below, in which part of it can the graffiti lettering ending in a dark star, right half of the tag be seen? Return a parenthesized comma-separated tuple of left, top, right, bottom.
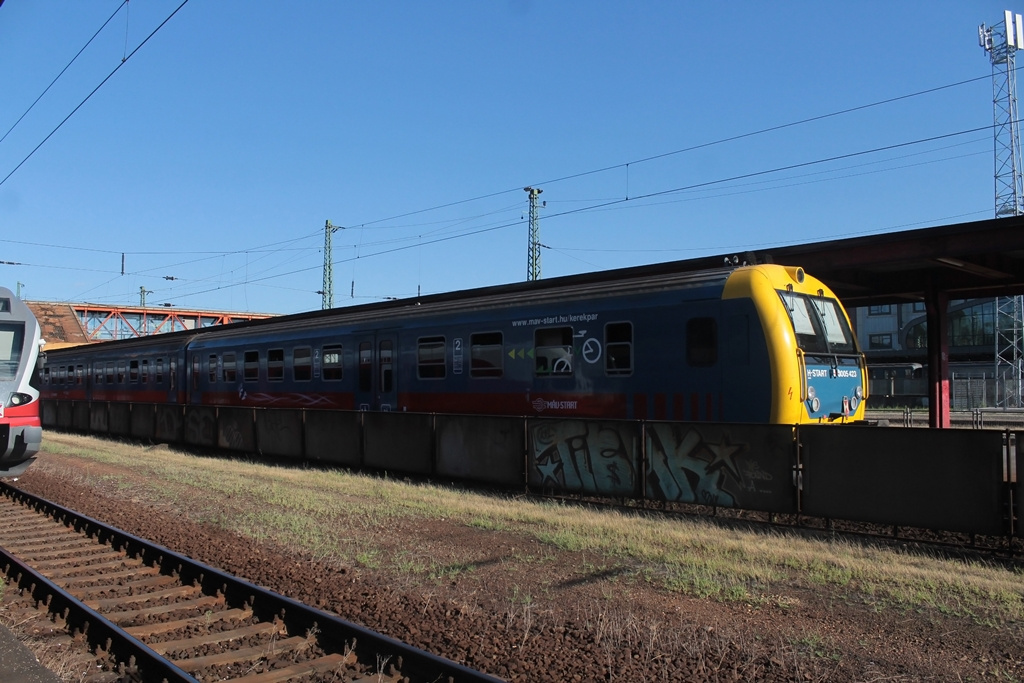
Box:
(647, 424, 753, 507)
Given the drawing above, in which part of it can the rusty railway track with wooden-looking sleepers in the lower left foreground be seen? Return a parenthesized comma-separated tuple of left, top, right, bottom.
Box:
(0, 483, 499, 683)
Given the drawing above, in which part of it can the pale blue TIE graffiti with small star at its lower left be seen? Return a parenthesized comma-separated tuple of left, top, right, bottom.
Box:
(529, 420, 639, 496)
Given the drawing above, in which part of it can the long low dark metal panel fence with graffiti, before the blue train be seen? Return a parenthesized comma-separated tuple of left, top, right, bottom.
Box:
(41, 400, 1024, 538)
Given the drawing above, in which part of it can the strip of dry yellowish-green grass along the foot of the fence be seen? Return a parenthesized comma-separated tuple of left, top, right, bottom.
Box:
(36, 433, 1024, 626)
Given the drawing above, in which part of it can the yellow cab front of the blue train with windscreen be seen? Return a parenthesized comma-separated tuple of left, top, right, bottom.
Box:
(722, 265, 867, 424)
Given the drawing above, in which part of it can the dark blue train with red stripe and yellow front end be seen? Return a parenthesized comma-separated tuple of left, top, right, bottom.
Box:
(42, 264, 867, 424)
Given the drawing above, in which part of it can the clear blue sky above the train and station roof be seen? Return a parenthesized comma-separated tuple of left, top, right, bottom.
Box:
(0, 0, 1011, 313)
